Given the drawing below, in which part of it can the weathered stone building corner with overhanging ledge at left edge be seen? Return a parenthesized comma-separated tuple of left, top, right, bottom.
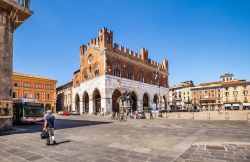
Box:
(0, 0, 32, 129)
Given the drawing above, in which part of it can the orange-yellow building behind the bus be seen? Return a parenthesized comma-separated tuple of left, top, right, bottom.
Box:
(12, 72, 57, 113)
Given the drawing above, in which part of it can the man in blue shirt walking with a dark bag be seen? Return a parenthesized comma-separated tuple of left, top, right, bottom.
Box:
(43, 110, 56, 145)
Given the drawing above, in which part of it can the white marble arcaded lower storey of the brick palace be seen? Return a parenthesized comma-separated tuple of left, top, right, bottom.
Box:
(72, 75, 169, 113)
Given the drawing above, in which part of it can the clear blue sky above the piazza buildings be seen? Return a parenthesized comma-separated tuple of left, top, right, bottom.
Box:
(14, 0, 250, 86)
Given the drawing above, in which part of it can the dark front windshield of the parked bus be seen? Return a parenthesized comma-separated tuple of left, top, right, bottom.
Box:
(24, 106, 44, 117)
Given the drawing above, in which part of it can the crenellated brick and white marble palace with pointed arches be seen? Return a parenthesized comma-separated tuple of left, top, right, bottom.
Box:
(72, 28, 169, 114)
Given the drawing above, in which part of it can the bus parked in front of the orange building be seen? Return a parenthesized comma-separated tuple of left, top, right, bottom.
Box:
(13, 99, 45, 123)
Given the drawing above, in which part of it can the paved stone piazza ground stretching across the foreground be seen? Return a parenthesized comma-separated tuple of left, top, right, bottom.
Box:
(0, 116, 250, 162)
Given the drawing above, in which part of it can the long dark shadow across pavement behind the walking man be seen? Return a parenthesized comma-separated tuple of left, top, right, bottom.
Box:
(0, 119, 113, 136)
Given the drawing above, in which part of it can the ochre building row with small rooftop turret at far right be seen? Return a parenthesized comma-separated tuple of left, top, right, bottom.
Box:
(191, 74, 250, 110)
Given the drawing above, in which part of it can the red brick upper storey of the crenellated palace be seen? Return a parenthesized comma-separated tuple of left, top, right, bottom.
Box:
(73, 28, 168, 87)
